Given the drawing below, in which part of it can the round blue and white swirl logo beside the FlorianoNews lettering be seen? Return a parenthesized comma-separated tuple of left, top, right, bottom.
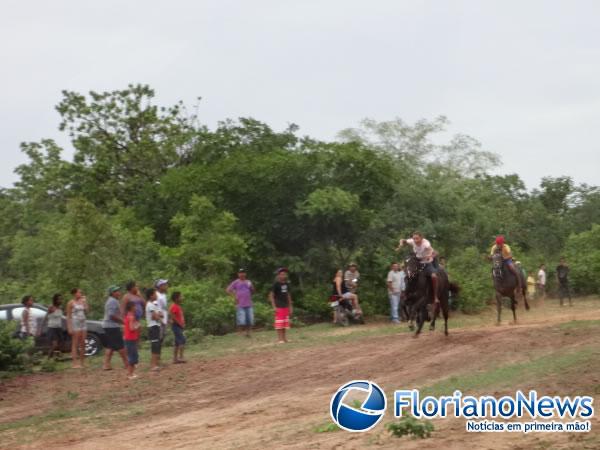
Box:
(330, 380, 387, 432)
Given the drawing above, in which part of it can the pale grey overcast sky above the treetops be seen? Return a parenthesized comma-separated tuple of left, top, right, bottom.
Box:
(0, 0, 600, 187)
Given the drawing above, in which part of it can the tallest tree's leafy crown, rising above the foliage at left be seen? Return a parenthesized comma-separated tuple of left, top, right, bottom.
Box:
(56, 84, 193, 206)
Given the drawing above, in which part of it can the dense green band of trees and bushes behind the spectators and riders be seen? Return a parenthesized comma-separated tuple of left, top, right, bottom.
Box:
(0, 85, 600, 333)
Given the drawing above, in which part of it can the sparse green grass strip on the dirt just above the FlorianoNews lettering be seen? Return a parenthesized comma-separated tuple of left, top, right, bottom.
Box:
(421, 347, 600, 396)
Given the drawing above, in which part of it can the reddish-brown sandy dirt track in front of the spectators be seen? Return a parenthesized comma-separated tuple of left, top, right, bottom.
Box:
(0, 300, 600, 449)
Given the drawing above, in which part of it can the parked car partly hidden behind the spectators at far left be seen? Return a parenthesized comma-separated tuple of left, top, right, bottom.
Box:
(0, 303, 104, 356)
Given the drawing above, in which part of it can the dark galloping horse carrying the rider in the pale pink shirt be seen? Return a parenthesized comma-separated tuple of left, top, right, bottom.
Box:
(405, 253, 458, 337)
